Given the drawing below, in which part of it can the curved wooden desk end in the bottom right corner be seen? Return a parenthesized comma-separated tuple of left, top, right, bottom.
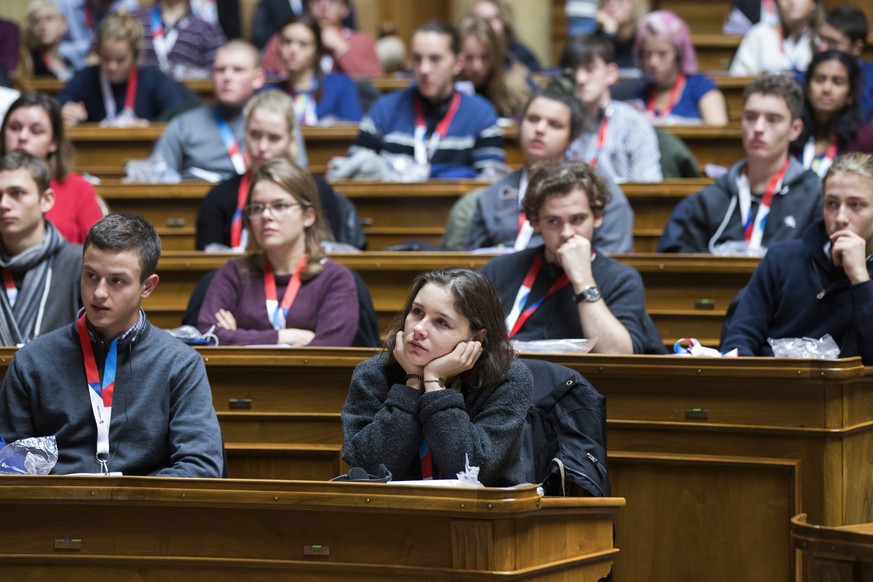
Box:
(791, 513, 873, 582)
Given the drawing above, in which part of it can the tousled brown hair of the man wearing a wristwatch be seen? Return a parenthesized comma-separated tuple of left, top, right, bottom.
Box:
(522, 161, 612, 221)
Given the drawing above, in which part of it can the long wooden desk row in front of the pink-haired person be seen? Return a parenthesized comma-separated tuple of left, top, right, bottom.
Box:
(69, 124, 745, 178)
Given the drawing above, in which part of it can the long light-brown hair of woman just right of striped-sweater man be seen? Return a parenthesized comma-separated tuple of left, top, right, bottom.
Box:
(458, 15, 531, 117)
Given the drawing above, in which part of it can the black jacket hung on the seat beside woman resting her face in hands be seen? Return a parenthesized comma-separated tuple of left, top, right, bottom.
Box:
(521, 359, 611, 497)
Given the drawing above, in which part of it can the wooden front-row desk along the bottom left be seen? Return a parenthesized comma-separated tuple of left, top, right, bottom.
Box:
(0, 477, 624, 582)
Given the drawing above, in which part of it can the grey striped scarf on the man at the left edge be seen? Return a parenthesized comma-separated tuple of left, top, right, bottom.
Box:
(0, 221, 65, 346)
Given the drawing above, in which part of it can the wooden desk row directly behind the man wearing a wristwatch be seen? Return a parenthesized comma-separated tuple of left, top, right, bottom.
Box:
(144, 251, 758, 345)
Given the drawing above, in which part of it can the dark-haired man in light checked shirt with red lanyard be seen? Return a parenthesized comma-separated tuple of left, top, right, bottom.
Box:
(560, 35, 664, 182)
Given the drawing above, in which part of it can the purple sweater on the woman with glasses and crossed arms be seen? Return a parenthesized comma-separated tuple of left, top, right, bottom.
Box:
(197, 257, 358, 347)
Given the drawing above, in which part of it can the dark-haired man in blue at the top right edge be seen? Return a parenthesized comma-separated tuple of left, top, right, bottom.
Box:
(816, 4, 873, 122)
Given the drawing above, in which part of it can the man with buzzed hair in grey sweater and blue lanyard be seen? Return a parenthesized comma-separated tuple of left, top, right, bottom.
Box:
(152, 40, 264, 182)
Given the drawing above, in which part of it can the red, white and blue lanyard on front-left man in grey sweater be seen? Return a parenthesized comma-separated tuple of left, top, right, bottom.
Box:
(76, 313, 118, 475)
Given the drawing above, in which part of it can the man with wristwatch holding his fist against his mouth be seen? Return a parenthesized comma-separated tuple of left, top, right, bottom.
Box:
(482, 162, 664, 354)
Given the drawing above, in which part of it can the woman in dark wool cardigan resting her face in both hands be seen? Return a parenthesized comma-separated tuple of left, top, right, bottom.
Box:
(342, 268, 533, 487)
